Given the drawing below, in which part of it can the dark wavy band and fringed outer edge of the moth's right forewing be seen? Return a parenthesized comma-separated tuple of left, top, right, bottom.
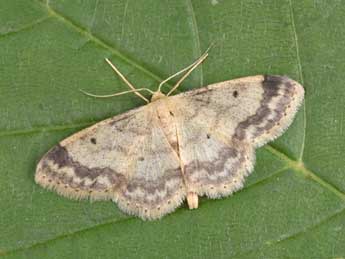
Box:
(233, 76, 304, 146)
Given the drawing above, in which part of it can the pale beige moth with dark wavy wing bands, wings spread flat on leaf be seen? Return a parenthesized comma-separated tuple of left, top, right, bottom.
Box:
(35, 49, 304, 220)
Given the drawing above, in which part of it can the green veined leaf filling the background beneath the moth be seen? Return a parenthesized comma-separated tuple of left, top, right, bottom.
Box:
(0, 0, 345, 258)
